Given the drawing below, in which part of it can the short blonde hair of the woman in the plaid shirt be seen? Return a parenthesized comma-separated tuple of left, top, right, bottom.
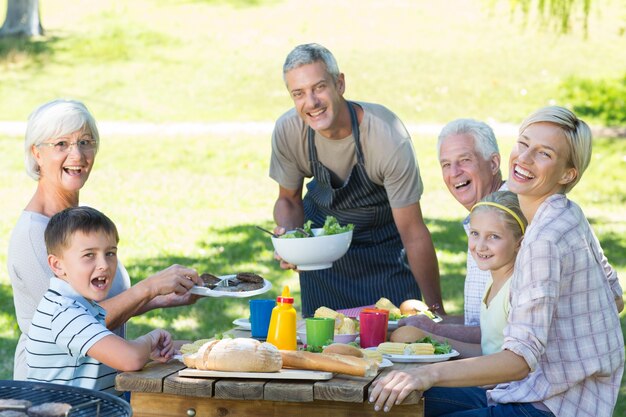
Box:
(519, 106, 592, 194)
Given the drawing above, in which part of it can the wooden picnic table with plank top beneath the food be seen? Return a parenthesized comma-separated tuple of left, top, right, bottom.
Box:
(116, 330, 424, 417)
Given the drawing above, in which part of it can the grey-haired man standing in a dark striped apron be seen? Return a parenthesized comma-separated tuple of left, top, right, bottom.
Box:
(270, 44, 444, 317)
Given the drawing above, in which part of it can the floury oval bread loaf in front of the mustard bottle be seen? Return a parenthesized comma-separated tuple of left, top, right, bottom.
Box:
(183, 338, 283, 372)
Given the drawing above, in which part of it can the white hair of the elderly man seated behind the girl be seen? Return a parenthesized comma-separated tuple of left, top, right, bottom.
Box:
(437, 119, 500, 161)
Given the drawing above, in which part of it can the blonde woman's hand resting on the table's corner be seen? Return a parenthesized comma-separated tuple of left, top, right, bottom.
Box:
(369, 367, 433, 412)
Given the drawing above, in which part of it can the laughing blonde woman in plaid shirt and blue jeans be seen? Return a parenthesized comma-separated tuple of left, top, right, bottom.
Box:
(370, 106, 624, 417)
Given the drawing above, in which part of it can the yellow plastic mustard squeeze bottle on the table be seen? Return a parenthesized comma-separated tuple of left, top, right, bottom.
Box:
(267, 285, 297, 350)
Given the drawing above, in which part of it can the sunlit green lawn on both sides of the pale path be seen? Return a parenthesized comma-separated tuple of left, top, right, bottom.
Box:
(0, 0, 626, 415)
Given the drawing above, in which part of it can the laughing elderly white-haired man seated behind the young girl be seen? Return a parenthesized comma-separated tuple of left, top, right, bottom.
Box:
(400, 119, 506, 343)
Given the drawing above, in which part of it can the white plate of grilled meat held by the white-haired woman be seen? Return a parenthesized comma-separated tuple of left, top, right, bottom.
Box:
(190, 272, 272, 298)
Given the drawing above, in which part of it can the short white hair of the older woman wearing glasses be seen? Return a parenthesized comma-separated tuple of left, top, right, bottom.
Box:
(24, 99, 100, 181)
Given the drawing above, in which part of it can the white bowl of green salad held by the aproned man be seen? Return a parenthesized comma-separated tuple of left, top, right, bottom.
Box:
(272, 216, 354, 271)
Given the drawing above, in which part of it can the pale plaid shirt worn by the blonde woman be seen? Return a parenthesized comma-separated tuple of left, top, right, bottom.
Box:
(488, 194, 624, 417)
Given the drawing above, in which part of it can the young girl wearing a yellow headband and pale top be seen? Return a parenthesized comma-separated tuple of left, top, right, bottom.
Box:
(416, 191, 527, 357)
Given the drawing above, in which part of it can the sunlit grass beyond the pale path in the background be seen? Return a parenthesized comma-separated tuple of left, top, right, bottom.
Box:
(0, 0, 626, 123)
